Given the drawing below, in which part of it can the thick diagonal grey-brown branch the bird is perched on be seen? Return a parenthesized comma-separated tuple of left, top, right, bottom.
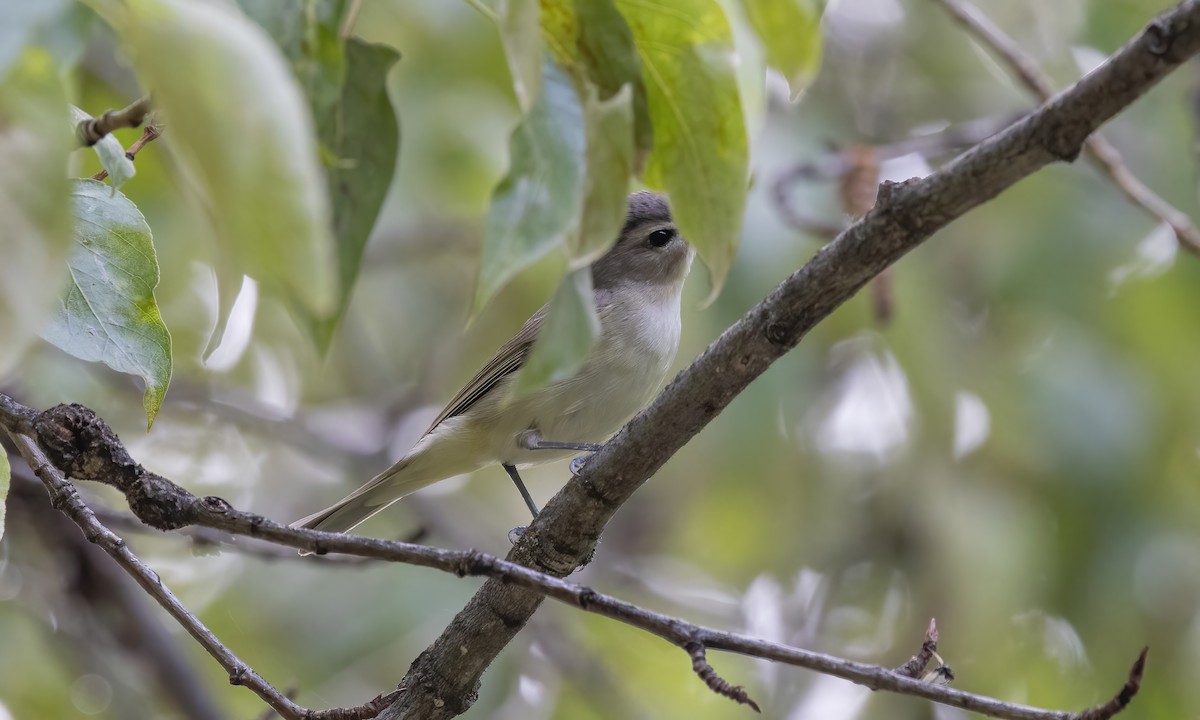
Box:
(382, 0, 1200, 720)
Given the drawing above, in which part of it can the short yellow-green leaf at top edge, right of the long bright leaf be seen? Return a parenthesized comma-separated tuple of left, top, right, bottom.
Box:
(742, 0, 822, 102)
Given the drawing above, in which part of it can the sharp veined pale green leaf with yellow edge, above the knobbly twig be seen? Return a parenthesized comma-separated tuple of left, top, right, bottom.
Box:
(43, 180, 172, 428)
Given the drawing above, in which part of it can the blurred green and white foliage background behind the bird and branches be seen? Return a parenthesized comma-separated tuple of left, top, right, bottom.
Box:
(0, 0, 1200, 720)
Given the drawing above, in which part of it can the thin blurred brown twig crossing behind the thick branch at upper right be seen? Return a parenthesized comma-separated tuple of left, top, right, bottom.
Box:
(936, 0, 1200, 256)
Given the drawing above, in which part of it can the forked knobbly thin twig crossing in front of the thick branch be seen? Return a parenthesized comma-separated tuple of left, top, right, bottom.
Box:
(0, 394, 1140, 720)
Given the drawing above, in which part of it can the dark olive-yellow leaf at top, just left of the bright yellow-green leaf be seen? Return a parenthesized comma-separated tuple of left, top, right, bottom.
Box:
(541, 0, 654, 169)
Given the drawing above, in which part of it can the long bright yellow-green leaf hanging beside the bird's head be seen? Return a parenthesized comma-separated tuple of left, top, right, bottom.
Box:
(617, 0, 749, 298)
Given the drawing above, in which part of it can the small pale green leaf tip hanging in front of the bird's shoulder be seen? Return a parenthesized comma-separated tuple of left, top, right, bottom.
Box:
(512, 268, 600, 397)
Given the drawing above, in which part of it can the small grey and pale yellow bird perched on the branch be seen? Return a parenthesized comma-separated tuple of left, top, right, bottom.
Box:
(293, 192, 695, 532)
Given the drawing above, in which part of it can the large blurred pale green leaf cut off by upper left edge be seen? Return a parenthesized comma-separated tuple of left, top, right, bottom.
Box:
(0, 48, 76, 378)
